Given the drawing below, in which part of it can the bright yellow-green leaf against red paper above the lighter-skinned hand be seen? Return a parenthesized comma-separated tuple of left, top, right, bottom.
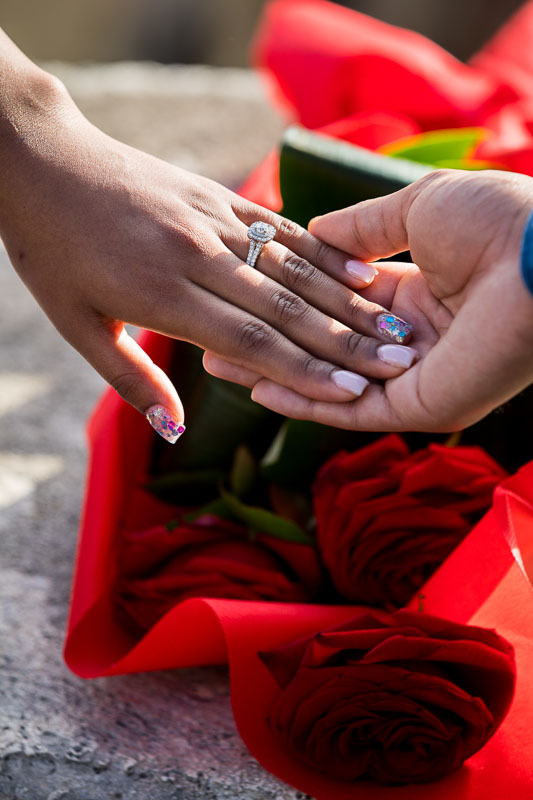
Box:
(380, 128, 486, 169)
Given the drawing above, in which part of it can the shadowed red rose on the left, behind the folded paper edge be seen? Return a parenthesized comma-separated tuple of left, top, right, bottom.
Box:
(116, 516, 321, 631)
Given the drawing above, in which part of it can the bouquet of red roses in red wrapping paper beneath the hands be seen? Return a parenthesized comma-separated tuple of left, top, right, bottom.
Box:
(65, 0, 533, 800)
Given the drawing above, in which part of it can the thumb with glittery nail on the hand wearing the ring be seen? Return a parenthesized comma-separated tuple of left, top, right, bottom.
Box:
(76, 322, 185, 444)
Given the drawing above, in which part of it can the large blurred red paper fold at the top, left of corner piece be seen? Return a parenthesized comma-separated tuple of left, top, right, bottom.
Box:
(251, 0, 517, 130)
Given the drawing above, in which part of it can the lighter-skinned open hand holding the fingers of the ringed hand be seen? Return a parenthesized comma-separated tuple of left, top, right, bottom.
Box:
(204, 170, 533, 431)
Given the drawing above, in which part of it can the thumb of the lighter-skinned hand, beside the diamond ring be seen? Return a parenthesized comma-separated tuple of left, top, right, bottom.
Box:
(309, 182, 418, 261)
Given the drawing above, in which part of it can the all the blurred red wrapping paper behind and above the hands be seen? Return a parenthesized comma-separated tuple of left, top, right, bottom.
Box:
(243, 0, 533, 210)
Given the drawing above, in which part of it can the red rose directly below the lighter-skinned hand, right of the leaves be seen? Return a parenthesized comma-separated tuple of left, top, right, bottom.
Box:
(313, 435, 506, 608)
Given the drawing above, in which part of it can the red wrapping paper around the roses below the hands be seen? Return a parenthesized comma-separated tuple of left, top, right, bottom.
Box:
(65, 334, 533, 800)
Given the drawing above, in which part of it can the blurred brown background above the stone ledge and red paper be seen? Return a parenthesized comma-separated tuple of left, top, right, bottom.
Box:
(0, 0, 521, 67)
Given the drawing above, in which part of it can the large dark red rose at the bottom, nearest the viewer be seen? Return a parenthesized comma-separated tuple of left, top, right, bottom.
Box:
(261, 611, 515, 784)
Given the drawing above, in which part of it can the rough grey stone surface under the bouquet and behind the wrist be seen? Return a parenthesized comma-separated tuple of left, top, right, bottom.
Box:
(0, 65, 303, 800)
